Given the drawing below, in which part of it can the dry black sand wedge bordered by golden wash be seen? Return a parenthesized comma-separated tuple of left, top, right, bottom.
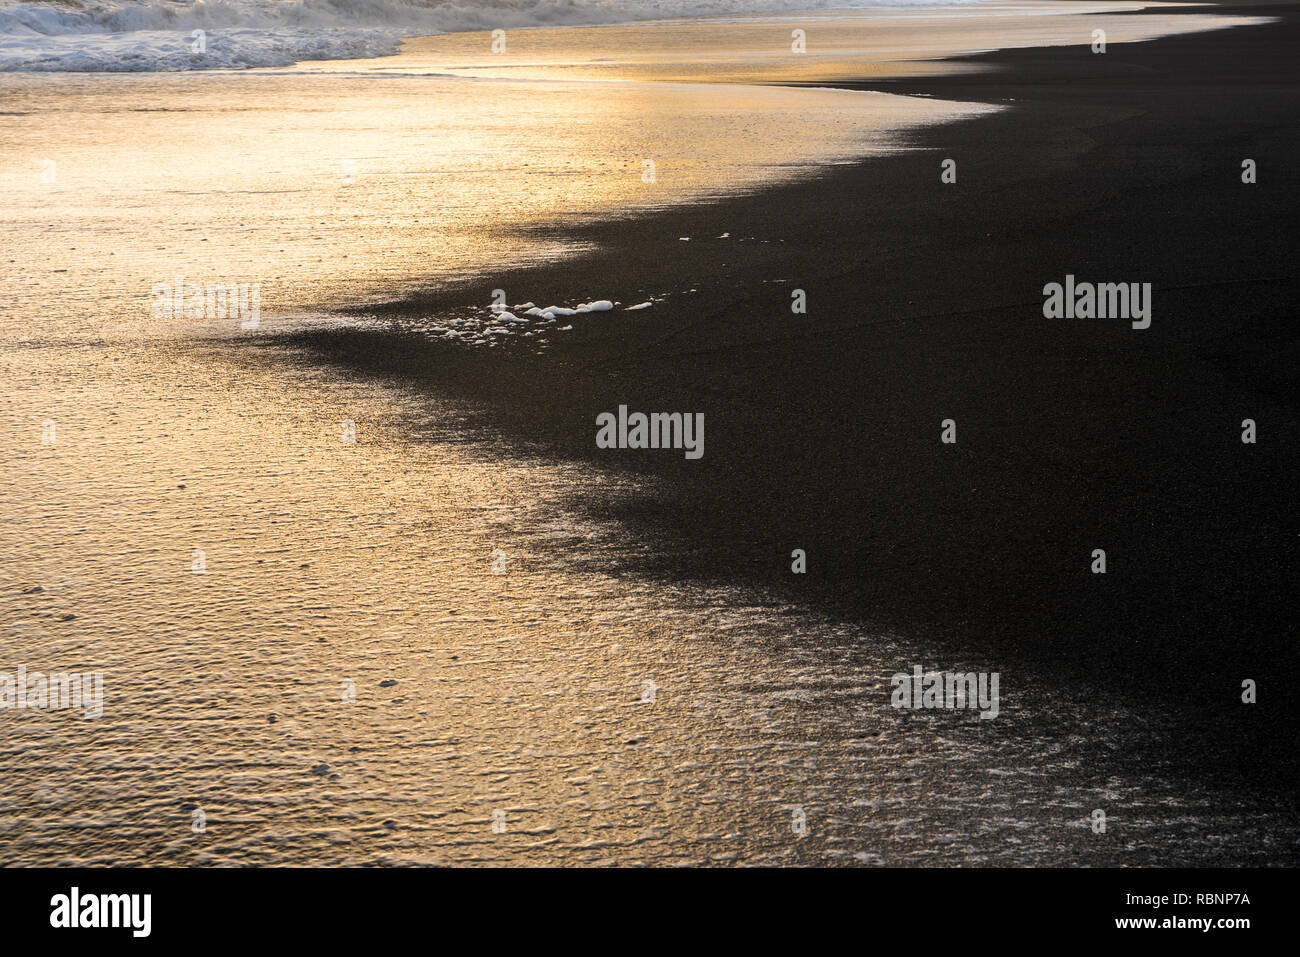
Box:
(267, 4, 1300, 800)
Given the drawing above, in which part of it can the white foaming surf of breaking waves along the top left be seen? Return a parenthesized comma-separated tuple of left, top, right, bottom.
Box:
(0, 0, 978, 73)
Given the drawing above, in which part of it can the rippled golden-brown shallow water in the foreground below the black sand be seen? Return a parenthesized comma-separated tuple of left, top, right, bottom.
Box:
(0, 330, 1278, 865)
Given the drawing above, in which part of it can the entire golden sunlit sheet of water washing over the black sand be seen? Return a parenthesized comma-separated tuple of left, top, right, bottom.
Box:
(0, 5, 1287, 865)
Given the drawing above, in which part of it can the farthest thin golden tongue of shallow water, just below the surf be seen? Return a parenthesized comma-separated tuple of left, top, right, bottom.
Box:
(327, 0, 1261, 83)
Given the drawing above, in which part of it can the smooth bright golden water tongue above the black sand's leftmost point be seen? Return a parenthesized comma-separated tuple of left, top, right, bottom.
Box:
(0, 64, 988, 338)
